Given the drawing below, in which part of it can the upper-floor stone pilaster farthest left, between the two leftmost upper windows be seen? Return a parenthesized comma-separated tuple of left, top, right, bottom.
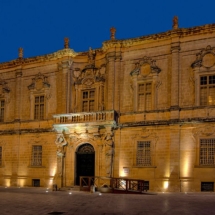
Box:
(15, 69, 22, 120)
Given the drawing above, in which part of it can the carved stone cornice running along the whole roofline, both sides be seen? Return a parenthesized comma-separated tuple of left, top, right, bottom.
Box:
(0, 23, 215, 69)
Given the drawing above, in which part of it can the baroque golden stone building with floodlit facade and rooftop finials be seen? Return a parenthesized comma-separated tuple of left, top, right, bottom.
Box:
(0, 17, 215, 192)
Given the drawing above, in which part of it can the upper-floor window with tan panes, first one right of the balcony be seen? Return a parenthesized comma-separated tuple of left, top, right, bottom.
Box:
(138, 83, 152, 111)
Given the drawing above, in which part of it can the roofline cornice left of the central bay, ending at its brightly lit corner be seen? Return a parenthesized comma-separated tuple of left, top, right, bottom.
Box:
(0, 48, 78, 69)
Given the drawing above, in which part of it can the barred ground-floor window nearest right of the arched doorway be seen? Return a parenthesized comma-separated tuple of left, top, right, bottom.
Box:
(136, 141, 151, 166)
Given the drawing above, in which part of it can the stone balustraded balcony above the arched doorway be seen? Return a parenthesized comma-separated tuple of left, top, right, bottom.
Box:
(53, 110, 117, 125)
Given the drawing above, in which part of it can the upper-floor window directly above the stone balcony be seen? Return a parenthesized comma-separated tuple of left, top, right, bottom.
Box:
(82, 90, 95, 112)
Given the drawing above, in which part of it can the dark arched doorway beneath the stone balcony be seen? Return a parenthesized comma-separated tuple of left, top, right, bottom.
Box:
(75, 143, 95, 185)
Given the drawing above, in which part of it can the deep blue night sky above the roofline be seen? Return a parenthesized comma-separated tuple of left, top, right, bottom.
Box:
(0, 0, 215, 62)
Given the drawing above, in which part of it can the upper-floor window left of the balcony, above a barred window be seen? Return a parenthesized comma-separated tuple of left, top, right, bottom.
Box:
(34, 96, 45, 119)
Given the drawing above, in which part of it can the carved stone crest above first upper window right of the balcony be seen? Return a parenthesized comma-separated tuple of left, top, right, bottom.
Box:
(130, 56, 161, 78)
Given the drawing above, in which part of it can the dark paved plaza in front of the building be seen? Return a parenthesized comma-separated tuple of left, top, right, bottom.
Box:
(0, 187, 215, 215)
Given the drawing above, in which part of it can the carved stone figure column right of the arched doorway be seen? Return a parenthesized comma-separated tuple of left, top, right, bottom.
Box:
(104, 131, 114, 177)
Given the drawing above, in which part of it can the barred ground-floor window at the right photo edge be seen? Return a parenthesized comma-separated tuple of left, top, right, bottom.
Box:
(199, 139, 215, 166)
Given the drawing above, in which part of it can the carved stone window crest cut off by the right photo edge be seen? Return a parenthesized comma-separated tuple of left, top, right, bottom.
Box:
(191, 46, 215, 69)
